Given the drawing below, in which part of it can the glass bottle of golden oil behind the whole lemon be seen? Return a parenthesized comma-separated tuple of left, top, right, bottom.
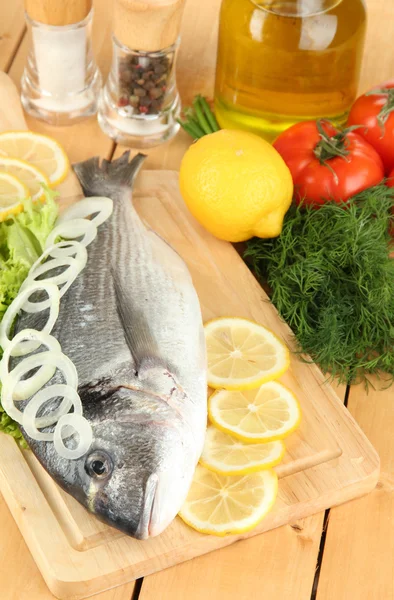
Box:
(215, 0, 366, 140)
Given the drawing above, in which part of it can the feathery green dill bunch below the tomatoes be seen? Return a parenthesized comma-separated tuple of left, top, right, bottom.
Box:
(244, 184, 394, 384)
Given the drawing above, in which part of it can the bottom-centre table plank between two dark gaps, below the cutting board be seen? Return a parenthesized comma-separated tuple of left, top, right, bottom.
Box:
(139, 513, 323, 600)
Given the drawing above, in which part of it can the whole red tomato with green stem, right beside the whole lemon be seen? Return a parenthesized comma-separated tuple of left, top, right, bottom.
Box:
(274, 121, 384, 205)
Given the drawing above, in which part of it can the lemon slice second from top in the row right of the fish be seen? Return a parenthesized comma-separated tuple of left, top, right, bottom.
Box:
(208, 381, 301, 442)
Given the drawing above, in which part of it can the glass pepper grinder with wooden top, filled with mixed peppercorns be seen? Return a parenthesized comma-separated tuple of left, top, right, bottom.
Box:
(98, 0, 185, 148)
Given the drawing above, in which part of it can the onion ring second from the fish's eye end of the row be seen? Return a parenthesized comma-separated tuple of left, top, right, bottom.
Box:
(22, 384, 82, 442)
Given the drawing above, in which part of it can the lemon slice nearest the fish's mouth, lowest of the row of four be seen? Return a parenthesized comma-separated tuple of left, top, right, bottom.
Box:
(179, 465, 278, 536)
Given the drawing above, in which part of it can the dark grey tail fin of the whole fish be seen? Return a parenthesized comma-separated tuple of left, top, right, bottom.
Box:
(73, 151, 146, 196)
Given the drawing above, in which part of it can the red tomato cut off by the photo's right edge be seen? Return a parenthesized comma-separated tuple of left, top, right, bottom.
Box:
(348, 81, 394, 175)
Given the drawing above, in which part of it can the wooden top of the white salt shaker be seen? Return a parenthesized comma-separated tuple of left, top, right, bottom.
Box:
(25, 0, 92, 26)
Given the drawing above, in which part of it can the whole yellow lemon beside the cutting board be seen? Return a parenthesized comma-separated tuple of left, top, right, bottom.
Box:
(179, 129, 293, 242)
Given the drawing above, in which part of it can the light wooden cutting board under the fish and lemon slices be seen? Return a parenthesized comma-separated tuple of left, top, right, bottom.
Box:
(0, 73, 379, 600)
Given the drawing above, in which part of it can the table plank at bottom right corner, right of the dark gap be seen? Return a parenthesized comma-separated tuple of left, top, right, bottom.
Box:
(317, 382, 394, 600)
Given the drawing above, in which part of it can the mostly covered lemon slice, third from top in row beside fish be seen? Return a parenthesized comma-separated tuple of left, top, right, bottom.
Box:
(200, 426, 285, 475)
